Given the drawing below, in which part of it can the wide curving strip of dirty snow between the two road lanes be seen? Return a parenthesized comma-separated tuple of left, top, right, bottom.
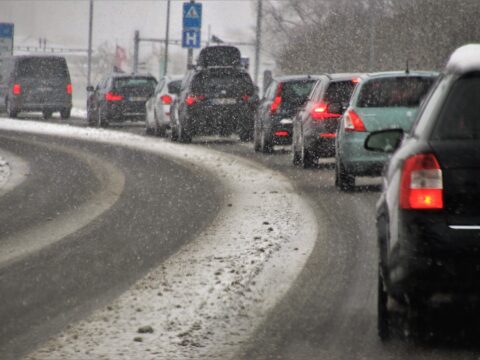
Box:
(0, 119, 318, 359)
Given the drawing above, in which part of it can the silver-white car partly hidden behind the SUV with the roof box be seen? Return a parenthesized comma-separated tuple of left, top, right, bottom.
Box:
(145, 75, 183, 136)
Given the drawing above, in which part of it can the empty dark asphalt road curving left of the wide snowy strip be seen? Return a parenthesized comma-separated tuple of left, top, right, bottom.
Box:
(0, 131, 224, 359)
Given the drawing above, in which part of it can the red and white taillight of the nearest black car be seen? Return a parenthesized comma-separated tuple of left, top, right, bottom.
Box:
(400, 154, 443, 210)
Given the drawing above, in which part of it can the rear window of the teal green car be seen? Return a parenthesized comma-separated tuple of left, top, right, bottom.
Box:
(357, 76, 435, 108)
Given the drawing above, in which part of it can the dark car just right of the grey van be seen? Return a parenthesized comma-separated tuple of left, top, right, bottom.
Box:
(87, 73, 157, 127)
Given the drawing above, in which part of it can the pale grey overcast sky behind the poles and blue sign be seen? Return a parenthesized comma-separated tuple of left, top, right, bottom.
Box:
(0, 0, 255, 57)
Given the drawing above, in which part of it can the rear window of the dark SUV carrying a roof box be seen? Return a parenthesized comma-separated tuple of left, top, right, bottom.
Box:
(192, 72, 254, 97)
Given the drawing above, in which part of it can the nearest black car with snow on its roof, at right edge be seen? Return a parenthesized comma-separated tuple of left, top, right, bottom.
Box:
(365, 45, 480, 339)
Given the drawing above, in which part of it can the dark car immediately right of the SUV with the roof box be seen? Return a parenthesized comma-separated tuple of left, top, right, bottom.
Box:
(253, 75, 320, 153)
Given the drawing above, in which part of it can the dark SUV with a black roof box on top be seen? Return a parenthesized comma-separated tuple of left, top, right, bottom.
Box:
(171, 46, 257, 142)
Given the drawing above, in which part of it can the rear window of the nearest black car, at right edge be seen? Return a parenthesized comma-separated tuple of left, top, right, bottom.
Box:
(433, 73, 480, 140)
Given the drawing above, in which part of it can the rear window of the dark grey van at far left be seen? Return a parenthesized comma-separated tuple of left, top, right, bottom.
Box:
(16, 57, 69, 80)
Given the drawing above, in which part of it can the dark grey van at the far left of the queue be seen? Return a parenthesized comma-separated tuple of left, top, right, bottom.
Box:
(0, 55, 72, 119)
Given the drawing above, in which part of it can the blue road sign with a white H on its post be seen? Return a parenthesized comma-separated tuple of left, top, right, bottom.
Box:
(182, 0, 202, 69)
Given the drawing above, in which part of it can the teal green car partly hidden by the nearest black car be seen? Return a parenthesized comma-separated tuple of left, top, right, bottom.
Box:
(335, 71, 438, 191)
